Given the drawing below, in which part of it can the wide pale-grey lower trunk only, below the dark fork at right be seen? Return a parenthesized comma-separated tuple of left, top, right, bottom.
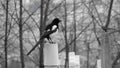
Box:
(101, 33, 112, 68)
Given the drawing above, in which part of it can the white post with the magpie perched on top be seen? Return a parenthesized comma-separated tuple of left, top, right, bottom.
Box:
(44, 43, 59, 68)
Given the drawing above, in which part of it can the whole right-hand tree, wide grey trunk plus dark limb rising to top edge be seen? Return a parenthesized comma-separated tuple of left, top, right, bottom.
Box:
(101, 0, 114, 68)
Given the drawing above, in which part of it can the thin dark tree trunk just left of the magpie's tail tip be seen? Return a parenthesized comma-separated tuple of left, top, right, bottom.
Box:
(19, 0, 25, 68)
